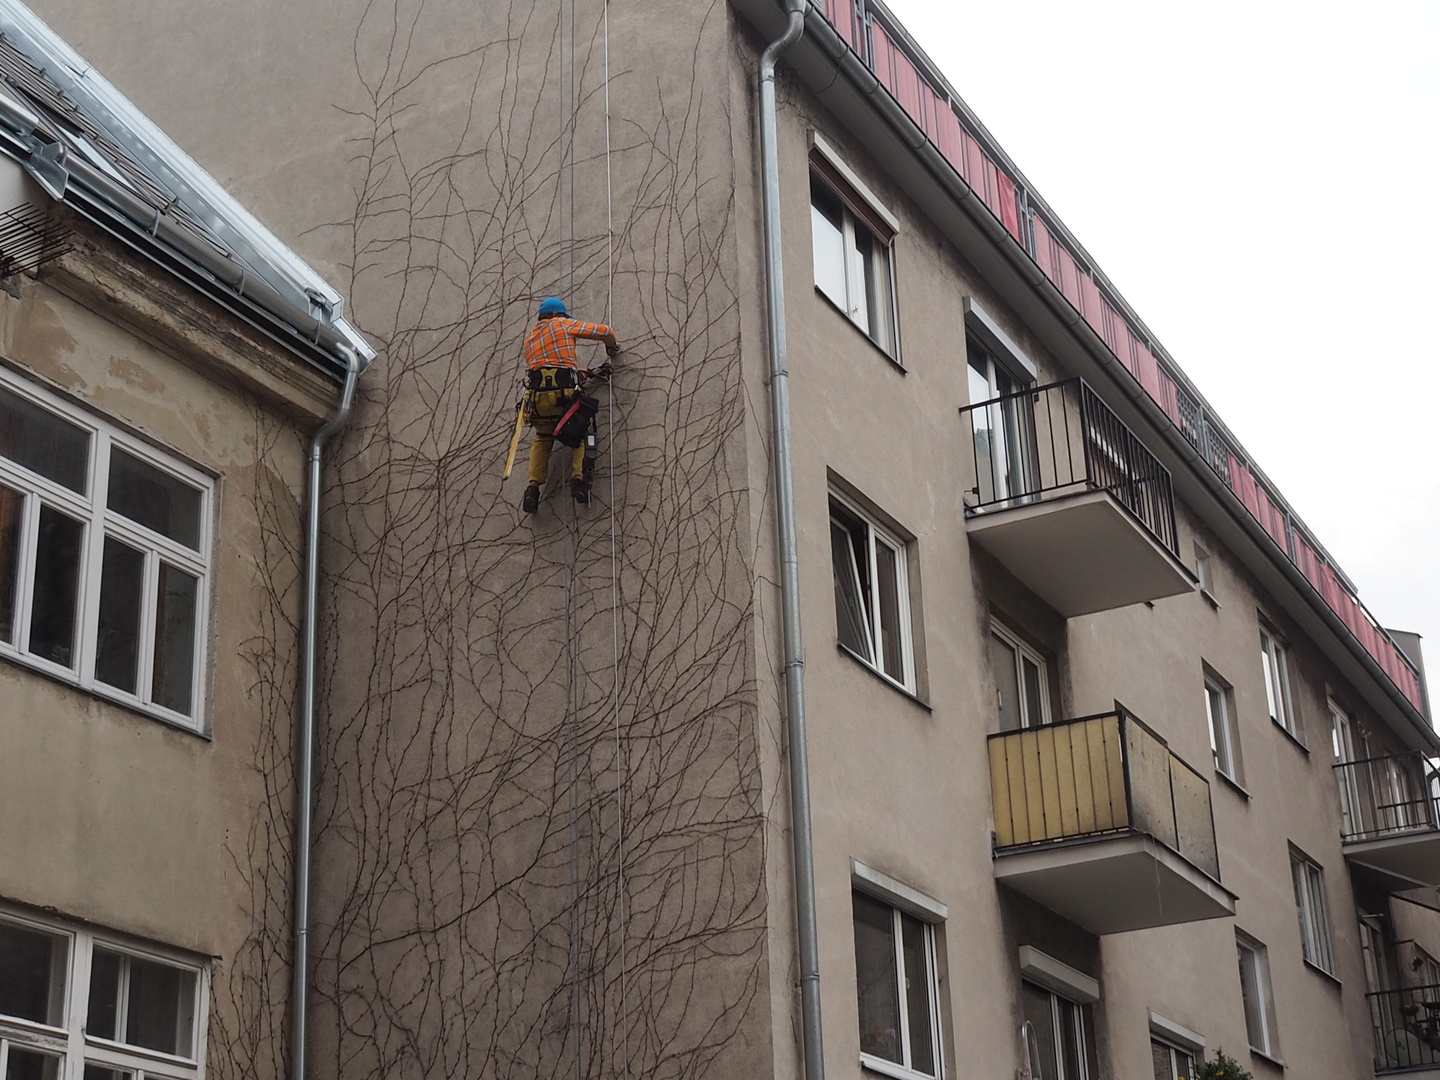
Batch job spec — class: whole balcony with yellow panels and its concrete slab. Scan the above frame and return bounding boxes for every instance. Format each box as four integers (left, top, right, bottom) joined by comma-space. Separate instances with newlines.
989, 706, 1236, 935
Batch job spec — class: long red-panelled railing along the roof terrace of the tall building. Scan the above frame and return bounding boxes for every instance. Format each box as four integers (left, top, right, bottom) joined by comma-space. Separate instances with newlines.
811, 0, 1424, 708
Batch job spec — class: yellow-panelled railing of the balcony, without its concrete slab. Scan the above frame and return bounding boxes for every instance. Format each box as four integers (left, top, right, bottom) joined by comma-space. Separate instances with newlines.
989, 706, 1220, 881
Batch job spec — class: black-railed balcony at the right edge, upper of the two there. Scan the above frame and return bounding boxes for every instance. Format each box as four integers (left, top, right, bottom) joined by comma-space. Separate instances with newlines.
1335, 753, 1440, 891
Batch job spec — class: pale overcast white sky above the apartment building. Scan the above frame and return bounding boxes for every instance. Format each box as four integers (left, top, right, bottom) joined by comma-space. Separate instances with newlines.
887, 0, 1440, 668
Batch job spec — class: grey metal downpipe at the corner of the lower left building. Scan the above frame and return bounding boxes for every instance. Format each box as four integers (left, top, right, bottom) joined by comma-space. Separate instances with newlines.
289, 346, 360, 1080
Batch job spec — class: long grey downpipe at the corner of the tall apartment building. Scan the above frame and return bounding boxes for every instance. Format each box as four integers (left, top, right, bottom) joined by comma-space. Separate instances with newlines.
760, 0, 825, 1080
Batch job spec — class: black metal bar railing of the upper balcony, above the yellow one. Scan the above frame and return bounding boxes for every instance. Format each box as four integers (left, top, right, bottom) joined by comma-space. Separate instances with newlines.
960, 379, 1178, 556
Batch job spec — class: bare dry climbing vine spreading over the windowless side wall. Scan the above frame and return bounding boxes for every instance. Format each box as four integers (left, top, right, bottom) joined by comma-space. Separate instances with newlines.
212, 0, 768, 1080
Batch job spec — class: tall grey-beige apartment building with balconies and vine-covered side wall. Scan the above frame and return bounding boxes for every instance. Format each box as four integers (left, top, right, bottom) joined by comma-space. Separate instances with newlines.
11, 0, 1440, 1080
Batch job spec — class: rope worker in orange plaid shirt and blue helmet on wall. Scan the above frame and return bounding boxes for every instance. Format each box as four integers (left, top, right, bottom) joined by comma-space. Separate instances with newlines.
507, 297, 621, 514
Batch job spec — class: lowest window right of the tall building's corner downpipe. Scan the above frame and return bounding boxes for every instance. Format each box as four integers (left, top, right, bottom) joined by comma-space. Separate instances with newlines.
851, 891, 940, 1076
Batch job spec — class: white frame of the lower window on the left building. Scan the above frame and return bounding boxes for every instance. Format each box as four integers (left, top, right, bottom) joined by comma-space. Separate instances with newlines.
0, 907, 210, 1080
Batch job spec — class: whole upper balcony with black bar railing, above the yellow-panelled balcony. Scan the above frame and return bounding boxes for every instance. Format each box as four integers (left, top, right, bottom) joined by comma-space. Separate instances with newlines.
960, 379, 1195, 618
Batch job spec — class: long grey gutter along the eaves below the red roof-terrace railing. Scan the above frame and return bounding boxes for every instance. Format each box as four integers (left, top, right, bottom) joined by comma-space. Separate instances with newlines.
732, 0, 1440, 752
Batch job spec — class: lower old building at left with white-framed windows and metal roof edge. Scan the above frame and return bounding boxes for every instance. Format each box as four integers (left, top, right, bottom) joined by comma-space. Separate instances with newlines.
0, 9, 369, 1080
